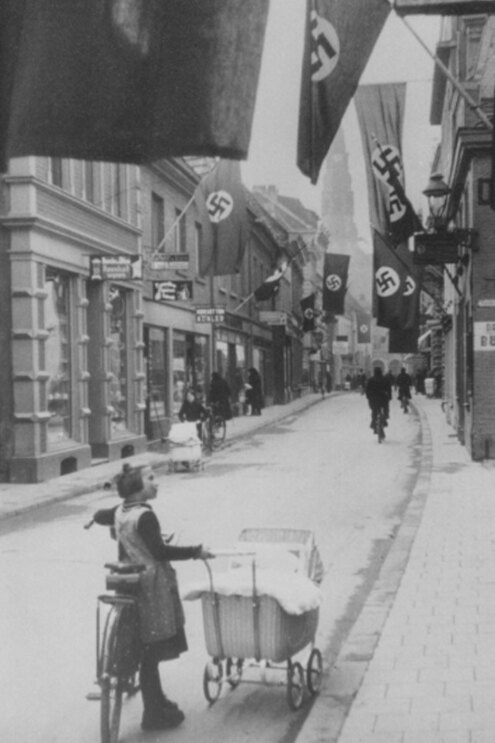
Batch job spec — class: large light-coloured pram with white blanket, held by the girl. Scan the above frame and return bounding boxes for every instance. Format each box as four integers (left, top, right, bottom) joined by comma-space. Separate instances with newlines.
184, 529, 323, 709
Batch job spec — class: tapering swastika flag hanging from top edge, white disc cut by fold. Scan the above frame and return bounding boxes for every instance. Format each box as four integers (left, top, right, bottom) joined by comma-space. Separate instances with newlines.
297, 0, 390, 183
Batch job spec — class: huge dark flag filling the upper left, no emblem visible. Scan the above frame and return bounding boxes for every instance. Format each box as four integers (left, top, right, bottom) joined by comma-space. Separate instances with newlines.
0, 0, 269, 170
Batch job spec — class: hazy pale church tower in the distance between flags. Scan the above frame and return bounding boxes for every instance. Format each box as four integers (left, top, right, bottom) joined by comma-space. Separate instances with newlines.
321, 127, 371, 308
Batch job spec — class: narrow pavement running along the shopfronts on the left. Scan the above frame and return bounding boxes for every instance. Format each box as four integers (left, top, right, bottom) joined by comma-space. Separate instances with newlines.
0, 393, 326, 519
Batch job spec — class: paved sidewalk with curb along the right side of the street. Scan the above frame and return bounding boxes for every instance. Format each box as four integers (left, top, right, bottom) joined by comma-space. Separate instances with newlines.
297, 396, 495, 743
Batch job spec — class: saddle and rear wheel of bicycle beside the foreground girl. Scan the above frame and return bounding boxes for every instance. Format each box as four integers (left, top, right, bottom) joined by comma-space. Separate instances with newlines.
96, 562, 145, 743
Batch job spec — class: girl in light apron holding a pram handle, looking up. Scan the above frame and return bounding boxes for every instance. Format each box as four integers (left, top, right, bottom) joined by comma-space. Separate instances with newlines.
93, 463, 213, 730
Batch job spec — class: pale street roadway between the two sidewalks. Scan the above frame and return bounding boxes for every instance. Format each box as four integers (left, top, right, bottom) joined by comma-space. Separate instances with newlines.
0, 393, 420, 743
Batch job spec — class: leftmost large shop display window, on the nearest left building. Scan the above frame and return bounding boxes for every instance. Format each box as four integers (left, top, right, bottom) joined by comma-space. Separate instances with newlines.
44, 268, 72, 449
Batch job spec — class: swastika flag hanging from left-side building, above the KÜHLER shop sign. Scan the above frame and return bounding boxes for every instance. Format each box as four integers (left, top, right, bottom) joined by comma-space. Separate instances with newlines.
196, 160, 249, 276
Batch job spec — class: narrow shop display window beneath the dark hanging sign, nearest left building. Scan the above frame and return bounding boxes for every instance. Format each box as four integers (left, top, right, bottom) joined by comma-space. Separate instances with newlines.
109, 285, 128, 434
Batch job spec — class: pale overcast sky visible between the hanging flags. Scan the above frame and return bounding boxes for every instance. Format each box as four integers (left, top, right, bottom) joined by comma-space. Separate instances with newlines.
243, 0, 440, 251
